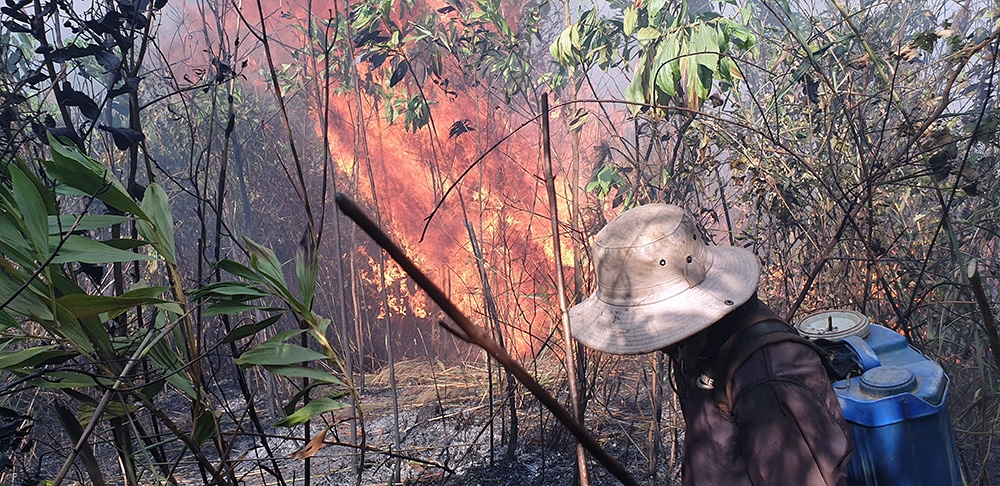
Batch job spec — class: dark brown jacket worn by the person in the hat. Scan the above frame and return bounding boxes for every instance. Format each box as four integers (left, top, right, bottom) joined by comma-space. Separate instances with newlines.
672, 299, 853, 486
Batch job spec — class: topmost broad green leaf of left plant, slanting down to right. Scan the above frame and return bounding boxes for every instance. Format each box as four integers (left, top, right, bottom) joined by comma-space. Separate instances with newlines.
43, 134, 146, 218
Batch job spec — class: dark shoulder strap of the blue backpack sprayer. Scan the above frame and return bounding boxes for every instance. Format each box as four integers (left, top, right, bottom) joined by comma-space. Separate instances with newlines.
715, 313, 833, 416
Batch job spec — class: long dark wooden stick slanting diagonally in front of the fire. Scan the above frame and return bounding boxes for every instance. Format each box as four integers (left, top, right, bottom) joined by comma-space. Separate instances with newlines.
337, 194, 639, 486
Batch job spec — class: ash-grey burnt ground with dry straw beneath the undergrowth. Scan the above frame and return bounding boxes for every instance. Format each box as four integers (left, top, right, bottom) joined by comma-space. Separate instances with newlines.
0, 357, 1000, 486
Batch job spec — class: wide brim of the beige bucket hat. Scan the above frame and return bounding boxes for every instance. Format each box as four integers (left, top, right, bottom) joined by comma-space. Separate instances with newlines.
569, 246, 760, 354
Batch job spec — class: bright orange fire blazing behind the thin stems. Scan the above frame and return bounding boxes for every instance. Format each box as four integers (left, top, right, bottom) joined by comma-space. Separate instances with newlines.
159, 1, 587, 356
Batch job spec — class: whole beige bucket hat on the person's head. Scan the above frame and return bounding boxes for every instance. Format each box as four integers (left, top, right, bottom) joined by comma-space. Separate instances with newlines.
569, 204, 760, 354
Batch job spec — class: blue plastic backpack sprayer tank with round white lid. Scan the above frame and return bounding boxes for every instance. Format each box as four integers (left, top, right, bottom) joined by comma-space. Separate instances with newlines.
795, 310, 962, 486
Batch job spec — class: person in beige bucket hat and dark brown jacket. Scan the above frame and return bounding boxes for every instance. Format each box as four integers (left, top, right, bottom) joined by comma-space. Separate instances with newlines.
569, 204, 853, 486
